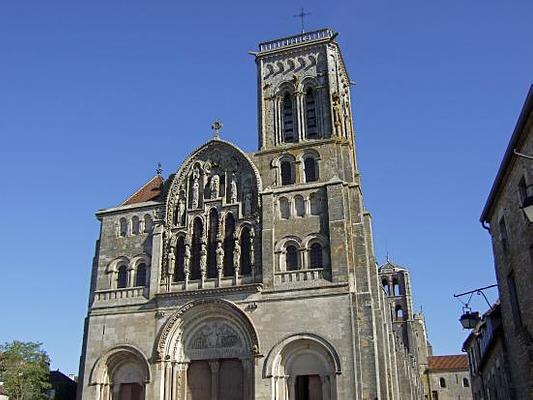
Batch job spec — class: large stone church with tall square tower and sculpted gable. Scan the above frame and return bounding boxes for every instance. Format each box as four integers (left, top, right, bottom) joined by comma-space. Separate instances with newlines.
78, 29, 427, 400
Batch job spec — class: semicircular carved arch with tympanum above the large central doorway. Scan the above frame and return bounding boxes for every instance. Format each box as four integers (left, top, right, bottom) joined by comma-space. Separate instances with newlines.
154, 299, 259, 362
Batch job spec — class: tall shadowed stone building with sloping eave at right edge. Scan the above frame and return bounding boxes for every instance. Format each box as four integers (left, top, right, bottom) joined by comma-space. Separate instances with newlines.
481, 87, 533, 400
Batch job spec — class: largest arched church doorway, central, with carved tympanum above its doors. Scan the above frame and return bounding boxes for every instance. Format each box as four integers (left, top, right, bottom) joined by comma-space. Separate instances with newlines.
156, 299, 259, 400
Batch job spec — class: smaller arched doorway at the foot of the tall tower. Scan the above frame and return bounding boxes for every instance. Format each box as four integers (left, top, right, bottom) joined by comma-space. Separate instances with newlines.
263, 334, 341, 400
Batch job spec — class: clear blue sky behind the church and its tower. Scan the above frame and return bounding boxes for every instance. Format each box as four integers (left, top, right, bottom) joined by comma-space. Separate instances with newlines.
0, 0, 533, 373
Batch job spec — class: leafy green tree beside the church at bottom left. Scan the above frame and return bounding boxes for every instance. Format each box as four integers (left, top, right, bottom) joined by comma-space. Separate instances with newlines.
0, 340, 50, 400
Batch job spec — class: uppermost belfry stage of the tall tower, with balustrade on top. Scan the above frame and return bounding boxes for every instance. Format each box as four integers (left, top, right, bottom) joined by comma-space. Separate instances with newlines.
255, 28, 353, 150
